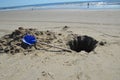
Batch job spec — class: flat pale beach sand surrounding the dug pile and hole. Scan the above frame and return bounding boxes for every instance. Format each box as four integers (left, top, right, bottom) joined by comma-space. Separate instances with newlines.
0, 9, 120, 80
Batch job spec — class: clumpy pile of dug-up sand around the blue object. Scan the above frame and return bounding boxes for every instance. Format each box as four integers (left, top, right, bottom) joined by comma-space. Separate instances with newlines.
0, 27, 67, 54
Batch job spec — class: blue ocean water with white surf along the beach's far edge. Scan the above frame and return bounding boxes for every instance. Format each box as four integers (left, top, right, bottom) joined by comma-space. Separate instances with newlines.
0, 0, 120, 10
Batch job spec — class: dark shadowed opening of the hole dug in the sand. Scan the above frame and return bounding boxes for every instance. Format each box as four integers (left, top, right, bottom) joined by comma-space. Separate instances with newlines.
68, 35, 98, 53
